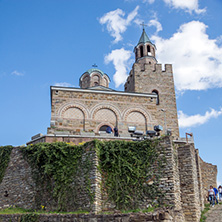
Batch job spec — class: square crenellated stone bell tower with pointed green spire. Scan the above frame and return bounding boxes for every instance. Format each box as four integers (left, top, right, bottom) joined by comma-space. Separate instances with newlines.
124, 27, 179, 138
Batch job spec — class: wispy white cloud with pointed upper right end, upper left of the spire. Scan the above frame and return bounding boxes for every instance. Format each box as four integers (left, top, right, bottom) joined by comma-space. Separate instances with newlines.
99, 6, 139, 43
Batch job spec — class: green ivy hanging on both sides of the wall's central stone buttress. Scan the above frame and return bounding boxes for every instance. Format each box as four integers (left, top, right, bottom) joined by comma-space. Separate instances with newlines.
22, 139, 164, 211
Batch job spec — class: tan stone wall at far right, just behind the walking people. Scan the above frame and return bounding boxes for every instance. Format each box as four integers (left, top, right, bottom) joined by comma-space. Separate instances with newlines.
200, 158, 217, 203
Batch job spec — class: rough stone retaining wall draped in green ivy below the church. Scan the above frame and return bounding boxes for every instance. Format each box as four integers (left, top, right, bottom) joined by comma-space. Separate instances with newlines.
0, 137, 181, 212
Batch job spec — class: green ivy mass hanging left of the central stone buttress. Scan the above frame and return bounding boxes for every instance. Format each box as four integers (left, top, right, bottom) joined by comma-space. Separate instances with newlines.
23, 142, 93, 211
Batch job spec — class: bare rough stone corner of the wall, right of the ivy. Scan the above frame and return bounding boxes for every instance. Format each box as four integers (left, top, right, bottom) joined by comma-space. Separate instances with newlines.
101, 137, 184, 222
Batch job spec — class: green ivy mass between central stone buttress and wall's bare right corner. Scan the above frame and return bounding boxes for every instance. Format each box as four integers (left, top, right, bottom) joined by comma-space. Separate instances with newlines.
96, 140, 163, 209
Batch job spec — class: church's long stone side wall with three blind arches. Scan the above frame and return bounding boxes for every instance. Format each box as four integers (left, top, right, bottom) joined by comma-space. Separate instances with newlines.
48, 87, 164, 136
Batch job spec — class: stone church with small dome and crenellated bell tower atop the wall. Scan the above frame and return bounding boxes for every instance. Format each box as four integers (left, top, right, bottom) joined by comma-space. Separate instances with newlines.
30, 29, 179, 143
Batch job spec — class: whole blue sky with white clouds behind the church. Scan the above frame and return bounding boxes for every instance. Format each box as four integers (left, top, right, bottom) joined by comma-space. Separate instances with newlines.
0, 0, 222, 185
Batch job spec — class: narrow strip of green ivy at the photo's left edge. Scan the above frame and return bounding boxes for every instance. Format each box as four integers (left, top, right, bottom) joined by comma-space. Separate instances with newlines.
0, 146, 12, 183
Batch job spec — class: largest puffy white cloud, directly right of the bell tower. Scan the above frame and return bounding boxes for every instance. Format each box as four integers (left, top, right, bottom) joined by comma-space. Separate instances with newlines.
151, 21, 222, 92
